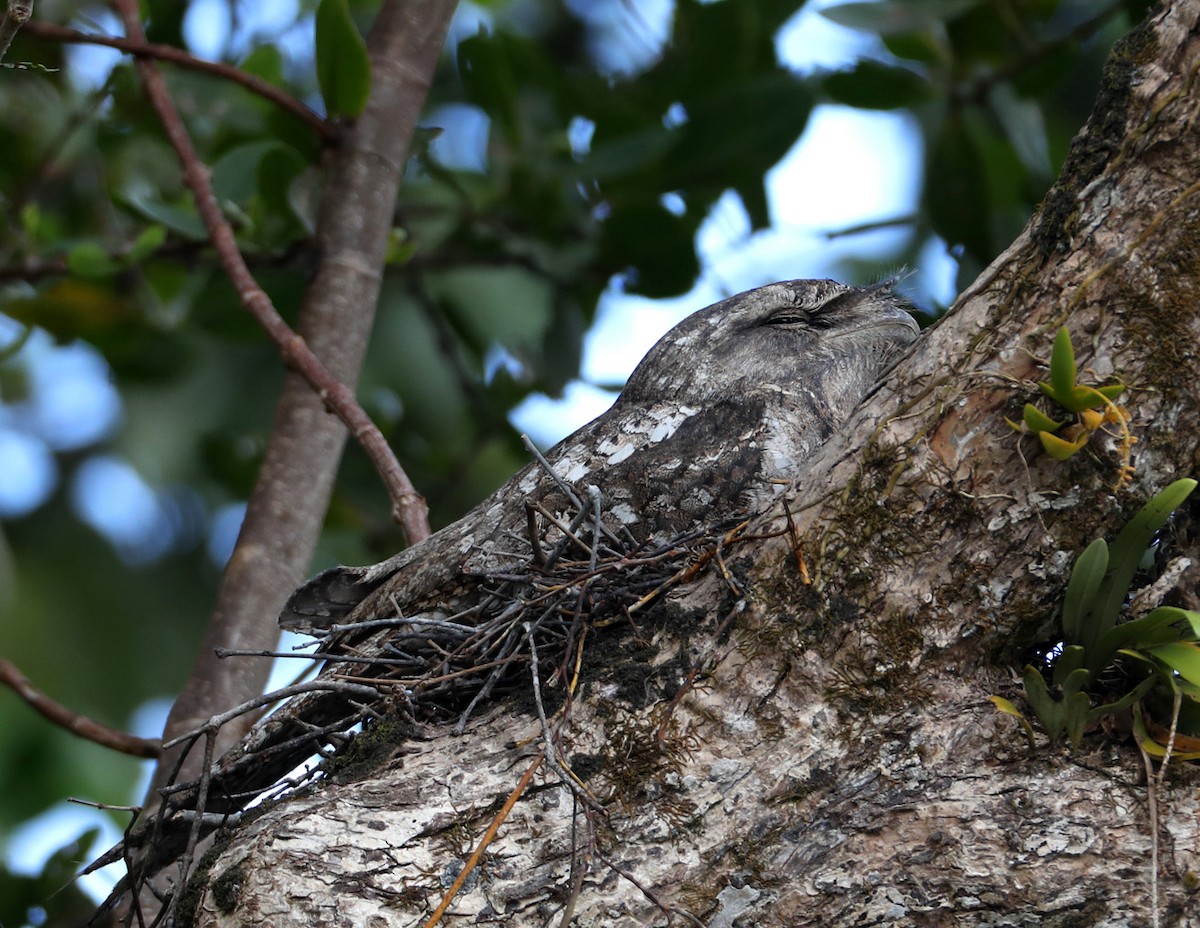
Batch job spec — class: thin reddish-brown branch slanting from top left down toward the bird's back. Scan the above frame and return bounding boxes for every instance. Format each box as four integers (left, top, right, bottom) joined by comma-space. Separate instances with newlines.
115, 0, 430, 545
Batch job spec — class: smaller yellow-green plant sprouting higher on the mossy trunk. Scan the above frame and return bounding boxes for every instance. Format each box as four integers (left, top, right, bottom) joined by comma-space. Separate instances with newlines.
1006, 327, 1136, 489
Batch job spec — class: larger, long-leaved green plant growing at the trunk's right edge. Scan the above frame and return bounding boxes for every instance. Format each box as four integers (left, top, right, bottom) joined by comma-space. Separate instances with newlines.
991, 479, 1200, 753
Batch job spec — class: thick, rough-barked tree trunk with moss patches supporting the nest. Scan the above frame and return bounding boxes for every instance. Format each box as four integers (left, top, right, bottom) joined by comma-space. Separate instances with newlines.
174, 0, 1200, 928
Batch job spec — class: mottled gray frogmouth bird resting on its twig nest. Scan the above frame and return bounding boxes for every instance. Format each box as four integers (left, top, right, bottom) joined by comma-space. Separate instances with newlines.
280, 280, 917, 630
